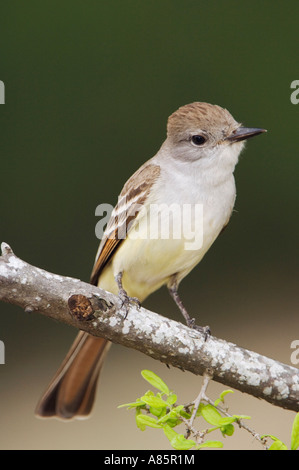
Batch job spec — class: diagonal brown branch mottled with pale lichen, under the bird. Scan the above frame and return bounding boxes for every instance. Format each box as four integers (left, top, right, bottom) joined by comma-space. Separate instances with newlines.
0, 243, 299, 411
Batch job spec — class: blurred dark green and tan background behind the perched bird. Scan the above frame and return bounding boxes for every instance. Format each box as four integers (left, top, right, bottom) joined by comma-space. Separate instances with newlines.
0, 0, 299, 449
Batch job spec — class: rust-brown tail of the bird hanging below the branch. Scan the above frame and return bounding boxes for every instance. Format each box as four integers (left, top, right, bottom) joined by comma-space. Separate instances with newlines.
36, 331, 111, 419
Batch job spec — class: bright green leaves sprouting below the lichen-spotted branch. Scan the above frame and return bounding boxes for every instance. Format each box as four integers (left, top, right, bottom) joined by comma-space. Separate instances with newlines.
119, 370, 299, 450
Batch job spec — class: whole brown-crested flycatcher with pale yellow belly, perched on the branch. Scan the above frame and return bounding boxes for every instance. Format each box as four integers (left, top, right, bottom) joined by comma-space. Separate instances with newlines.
36, 102, 265, 419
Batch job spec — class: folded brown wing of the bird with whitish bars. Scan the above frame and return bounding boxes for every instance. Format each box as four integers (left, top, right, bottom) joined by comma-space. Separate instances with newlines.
90, 162, 160, 285
